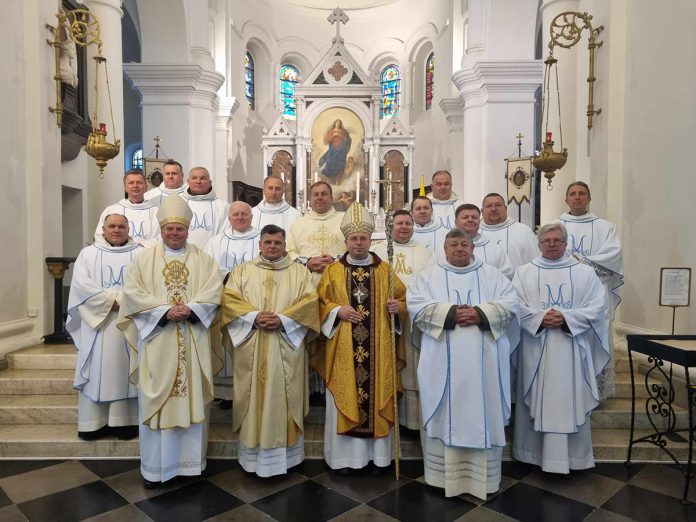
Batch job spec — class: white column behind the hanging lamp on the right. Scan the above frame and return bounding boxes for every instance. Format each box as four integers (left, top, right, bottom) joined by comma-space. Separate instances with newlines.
540, 0, 589, 223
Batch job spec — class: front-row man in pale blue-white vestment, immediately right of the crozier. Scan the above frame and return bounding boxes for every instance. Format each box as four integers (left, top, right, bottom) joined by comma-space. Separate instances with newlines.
407, 229, 519, 499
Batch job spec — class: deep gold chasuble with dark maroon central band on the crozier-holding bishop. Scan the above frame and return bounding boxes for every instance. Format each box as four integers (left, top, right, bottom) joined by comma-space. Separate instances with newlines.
311, 253, 407, 438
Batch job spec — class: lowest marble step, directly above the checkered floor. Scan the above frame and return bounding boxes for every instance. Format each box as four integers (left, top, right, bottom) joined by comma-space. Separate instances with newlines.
0, 424, 688, 462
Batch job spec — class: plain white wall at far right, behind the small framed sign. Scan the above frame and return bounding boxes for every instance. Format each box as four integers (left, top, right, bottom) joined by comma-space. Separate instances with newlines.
610, 0, 696, 333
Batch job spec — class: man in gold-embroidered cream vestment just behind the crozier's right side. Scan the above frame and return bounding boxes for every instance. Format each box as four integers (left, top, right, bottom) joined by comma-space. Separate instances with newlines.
373, 210, 433, 430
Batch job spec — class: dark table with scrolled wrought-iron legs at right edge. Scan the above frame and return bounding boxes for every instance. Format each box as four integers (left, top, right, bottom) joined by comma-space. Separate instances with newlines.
626, 335, 696, 503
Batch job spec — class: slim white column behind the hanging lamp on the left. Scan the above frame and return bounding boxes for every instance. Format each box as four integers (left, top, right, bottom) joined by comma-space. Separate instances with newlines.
84, 0, 124, 230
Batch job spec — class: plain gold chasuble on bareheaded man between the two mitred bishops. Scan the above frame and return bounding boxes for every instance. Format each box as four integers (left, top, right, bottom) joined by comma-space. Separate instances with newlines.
221, 255, 319, 449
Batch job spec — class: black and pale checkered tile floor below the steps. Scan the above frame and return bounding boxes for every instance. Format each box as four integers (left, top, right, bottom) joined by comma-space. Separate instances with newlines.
0, 460, 696, 522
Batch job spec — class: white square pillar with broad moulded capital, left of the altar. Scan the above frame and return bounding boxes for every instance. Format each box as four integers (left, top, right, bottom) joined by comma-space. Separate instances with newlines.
123, 63, 224, 175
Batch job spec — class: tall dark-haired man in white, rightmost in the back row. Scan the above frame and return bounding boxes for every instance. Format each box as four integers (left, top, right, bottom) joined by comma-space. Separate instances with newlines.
560, 181, 624, 400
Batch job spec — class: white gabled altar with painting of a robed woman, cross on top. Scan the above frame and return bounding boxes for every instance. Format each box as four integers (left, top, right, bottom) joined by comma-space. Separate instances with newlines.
261, 9, 419, 224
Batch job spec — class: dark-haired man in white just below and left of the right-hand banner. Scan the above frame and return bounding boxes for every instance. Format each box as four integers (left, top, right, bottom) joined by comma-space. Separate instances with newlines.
480, 192, 539, 269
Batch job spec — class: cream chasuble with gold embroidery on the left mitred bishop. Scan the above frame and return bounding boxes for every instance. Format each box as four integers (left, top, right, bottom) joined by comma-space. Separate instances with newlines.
118, 243, 222, 429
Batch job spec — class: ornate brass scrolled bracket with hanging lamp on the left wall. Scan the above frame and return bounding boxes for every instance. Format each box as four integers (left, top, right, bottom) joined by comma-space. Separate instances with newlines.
46, 9, 121, 177
